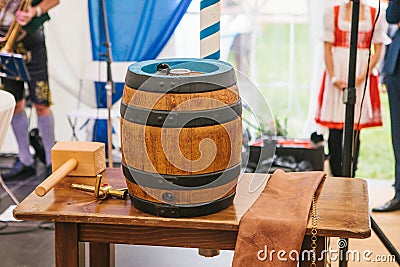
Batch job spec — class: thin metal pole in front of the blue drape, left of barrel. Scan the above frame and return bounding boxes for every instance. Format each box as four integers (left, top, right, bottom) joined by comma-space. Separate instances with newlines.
101, 0, 115, 168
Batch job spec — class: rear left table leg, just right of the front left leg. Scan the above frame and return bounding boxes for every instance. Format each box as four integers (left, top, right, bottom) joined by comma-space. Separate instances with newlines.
89, 242, 115, 267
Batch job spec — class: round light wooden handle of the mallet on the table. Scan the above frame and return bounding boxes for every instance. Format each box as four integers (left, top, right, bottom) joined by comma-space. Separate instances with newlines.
35, 158, 78, 197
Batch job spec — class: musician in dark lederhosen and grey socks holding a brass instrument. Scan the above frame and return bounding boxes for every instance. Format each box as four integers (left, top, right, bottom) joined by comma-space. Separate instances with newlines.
0, 0, 59, 180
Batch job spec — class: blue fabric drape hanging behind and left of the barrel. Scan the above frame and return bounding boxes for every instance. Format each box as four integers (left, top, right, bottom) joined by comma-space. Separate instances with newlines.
88, 0, 191, 147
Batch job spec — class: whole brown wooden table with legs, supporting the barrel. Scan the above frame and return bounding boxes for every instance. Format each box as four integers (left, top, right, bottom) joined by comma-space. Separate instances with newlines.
14, 168, 371, 267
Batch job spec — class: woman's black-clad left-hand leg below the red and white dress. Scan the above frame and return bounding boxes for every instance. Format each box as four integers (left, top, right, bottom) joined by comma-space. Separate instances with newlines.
328, 129, 343, 176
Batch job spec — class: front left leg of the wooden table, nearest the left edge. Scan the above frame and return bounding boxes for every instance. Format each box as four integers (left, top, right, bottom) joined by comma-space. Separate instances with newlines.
55, 223, 79, 267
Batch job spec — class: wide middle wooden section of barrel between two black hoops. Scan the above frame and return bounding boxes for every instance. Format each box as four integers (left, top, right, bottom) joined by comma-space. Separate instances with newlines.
121, 118, 242, 175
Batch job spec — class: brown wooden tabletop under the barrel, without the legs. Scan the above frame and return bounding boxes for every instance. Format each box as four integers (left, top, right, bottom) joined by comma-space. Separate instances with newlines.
14, 168, 371, 238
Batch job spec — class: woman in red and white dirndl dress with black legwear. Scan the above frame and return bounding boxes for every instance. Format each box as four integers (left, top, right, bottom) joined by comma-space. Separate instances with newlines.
315, 1, 387, 179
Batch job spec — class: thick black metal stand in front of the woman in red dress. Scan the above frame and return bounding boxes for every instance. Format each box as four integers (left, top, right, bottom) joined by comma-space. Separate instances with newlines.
339, 0, 400, 267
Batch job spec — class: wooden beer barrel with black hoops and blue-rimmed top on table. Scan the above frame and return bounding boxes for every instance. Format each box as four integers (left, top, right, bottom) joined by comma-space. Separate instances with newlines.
120, 59, 242, 217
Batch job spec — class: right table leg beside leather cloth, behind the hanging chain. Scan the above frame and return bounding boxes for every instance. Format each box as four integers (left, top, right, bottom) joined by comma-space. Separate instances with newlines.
299, 236, 327, 267
